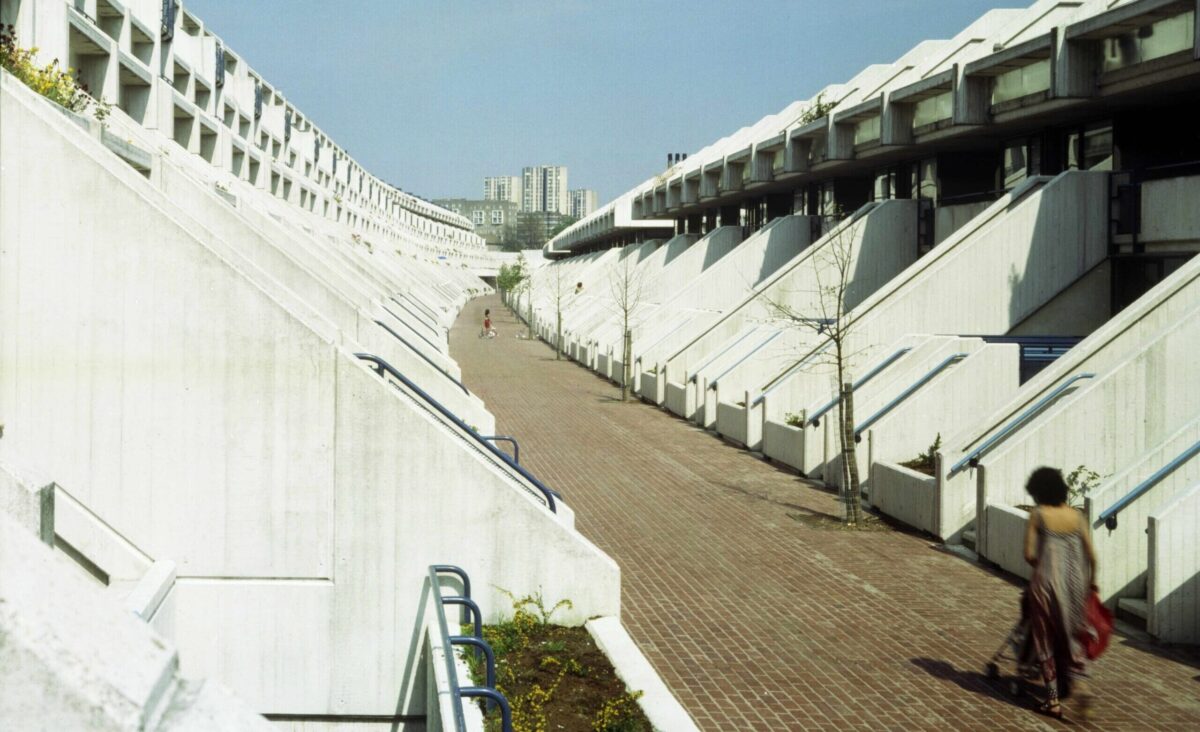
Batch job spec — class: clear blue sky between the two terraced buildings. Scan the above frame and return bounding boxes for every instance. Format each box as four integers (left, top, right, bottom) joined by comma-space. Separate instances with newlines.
185, 0, 1012, 202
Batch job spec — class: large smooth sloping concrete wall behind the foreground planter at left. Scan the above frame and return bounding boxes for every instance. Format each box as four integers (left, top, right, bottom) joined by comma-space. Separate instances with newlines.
0, 68, 619, 715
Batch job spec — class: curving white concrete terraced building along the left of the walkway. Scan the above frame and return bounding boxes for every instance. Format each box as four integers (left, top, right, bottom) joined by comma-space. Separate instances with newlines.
0, 0, 686, 731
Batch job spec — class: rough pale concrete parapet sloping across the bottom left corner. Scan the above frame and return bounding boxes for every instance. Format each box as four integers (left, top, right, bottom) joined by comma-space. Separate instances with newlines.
0, 511, 270, 732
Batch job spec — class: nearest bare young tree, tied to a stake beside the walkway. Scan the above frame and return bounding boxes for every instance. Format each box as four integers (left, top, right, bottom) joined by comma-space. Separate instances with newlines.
767, 211, 863, 526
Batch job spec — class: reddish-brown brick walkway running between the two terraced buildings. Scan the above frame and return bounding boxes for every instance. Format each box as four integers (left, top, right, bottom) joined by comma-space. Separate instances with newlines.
451, 298, 1200, 731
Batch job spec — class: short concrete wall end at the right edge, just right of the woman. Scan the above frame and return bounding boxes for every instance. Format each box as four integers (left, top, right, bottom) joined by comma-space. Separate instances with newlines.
1146, 484, 1200, 643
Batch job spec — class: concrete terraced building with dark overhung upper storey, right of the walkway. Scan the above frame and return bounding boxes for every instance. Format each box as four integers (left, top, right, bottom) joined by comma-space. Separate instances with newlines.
535, 0, 1200, 643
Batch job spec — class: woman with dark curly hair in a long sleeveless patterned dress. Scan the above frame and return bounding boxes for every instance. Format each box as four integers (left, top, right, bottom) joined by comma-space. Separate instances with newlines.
1025, 468, 1096, 719
